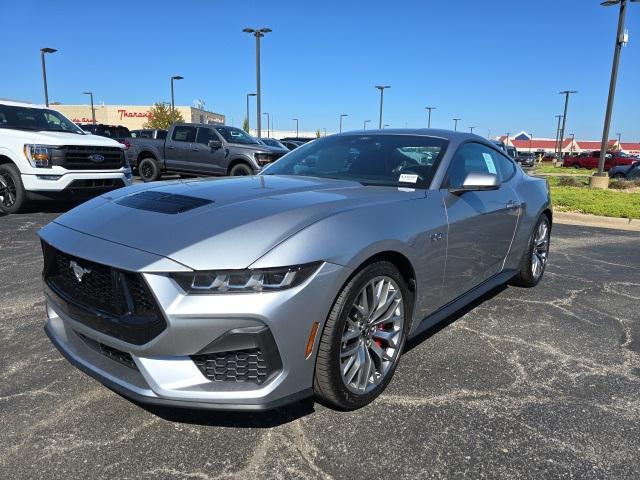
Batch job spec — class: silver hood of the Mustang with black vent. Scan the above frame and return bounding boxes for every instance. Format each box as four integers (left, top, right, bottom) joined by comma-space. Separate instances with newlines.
55, 175, 425, 270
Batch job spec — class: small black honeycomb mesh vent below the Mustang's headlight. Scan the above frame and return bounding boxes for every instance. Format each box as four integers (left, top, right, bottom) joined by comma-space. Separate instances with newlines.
191, 348, 270, 385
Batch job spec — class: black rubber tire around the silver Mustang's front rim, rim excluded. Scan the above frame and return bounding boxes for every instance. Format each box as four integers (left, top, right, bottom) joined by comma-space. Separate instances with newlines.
313, 261, 413, 410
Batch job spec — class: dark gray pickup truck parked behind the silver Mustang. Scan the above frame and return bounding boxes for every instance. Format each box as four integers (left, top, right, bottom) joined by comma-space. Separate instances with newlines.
127, 123, 288, 182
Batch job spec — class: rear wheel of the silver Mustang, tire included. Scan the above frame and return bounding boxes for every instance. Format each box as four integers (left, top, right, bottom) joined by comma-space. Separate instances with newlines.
511, 215, 551, 287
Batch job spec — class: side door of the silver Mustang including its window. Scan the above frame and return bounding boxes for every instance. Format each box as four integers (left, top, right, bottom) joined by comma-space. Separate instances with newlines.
440, 142, 520, 301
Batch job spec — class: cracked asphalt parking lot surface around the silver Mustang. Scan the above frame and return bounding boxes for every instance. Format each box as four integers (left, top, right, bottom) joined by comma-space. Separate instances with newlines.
0, 208, 640, 479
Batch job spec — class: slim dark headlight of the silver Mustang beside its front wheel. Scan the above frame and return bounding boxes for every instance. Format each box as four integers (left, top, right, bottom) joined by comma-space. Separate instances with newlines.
171, 262, 322, 294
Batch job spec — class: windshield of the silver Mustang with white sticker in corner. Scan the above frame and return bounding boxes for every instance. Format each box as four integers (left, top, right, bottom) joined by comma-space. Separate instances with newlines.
263, 135, 447, 188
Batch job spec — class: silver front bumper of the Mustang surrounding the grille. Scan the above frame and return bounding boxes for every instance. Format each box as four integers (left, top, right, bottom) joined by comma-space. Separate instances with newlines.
45, 232, 350, 410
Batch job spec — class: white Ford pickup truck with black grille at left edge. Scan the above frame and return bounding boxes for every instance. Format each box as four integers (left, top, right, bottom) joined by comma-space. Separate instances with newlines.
0, 99, 132, 213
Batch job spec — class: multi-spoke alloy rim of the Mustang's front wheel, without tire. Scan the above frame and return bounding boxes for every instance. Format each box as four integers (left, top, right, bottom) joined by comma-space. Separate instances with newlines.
340, 276, 405, 394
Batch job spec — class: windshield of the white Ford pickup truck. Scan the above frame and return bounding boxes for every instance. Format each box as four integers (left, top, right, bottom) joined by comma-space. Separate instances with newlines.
0, 104, 84, 135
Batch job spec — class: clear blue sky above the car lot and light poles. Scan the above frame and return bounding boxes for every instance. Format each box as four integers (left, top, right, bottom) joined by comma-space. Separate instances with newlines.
0, 0, 640, 141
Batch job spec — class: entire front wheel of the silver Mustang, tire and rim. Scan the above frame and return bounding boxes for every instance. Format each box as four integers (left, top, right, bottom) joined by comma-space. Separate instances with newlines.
313, 261, 411, 410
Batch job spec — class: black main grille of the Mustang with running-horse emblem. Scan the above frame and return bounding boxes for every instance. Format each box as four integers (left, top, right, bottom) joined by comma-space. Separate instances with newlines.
42, 242, 167, 345
